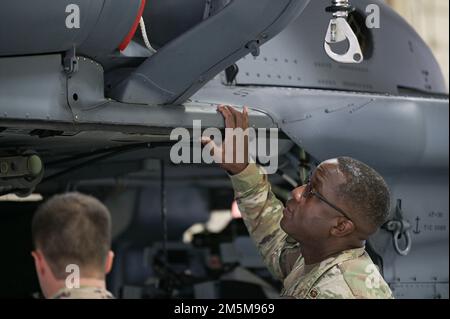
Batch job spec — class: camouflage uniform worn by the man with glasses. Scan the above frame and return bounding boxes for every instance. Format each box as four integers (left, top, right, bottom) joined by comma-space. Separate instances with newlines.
230, 164, 393, 299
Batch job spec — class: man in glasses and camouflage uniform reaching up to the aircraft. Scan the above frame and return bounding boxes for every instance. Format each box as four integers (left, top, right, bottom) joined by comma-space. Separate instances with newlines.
202, 106, 393, 299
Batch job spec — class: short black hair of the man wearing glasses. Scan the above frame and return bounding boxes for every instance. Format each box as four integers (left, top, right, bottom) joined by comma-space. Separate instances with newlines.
338, 157, 391, 233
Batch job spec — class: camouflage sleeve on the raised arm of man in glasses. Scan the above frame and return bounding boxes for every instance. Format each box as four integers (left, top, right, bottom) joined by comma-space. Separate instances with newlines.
230, 164, 300, 280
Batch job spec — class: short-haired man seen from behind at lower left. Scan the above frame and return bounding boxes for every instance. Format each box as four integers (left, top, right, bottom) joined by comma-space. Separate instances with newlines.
32, 193, 114, 299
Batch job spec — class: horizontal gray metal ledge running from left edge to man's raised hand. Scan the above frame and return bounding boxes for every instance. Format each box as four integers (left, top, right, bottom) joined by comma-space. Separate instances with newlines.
0, 55, 274, 133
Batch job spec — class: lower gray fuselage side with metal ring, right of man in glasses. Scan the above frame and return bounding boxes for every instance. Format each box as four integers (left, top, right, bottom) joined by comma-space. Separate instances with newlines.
372, 172, 449, 298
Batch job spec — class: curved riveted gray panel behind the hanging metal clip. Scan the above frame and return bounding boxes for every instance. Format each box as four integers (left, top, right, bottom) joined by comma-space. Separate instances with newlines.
236, 0, 448, 94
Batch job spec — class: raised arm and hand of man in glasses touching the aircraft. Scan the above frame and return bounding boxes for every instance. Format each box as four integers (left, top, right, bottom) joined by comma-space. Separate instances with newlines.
202, 106, 299, 279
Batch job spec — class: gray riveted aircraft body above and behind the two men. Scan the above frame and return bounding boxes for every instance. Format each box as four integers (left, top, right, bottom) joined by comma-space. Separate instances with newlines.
0, 0, 449, 298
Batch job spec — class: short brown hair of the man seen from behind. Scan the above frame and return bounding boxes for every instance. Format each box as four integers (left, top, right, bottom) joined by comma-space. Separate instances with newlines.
31, 192, 111, 279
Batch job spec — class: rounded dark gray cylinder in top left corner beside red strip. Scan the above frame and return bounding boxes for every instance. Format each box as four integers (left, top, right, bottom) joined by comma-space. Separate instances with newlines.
0, 0, 141, 57
